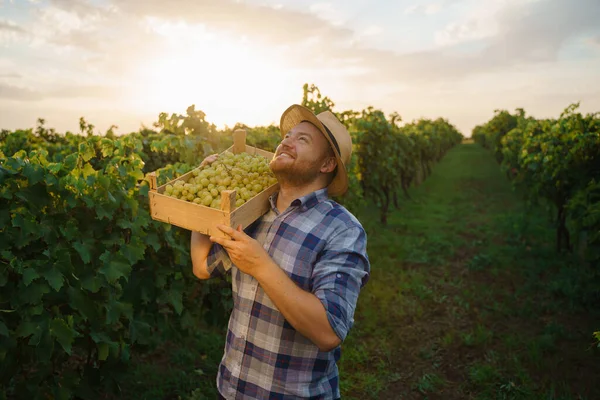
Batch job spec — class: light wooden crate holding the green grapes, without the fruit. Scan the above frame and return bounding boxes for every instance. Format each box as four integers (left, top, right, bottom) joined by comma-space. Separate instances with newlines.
149, 129, 279, 237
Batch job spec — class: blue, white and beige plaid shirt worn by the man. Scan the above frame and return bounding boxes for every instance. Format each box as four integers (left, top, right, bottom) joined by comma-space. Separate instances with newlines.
207, 189, 370, 400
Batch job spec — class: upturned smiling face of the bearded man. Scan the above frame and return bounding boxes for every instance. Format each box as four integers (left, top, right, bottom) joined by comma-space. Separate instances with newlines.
270, 122, 335, 185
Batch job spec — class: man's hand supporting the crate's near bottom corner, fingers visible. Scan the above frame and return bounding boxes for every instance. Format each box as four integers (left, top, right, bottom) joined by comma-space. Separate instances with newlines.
210, 225, 272, 278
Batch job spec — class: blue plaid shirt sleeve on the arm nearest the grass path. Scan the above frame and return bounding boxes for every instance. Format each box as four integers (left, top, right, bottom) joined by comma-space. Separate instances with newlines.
312, 225, 370, 341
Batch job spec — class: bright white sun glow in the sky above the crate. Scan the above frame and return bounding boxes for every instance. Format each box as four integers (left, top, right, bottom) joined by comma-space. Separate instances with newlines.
132, 19, 298, 126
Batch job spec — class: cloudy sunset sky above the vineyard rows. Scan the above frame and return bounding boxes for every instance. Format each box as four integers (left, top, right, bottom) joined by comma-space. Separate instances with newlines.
0, 0, 600, 136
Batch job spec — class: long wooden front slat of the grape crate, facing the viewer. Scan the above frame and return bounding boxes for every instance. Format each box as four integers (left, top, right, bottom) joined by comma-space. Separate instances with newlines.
149, 192, 231, 237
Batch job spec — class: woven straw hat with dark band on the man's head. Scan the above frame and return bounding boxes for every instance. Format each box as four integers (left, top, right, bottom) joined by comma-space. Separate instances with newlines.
279, 104, 352, 196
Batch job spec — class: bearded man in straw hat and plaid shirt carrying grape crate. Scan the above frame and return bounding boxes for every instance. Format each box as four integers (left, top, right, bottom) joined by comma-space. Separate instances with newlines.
191, 105, 370, 399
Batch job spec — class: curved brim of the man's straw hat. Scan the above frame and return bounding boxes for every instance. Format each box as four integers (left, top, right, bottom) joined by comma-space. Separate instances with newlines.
279, 104, 348, 196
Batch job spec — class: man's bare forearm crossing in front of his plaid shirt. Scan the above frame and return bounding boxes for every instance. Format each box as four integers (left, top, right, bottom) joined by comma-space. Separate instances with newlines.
255, 260, 341, 351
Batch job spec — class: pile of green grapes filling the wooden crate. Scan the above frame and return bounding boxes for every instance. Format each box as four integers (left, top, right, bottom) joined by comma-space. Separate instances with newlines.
165, 151, 277, 208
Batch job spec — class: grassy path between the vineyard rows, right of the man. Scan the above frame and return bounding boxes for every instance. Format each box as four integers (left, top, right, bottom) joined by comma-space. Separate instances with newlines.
340, 144, 600, 399
